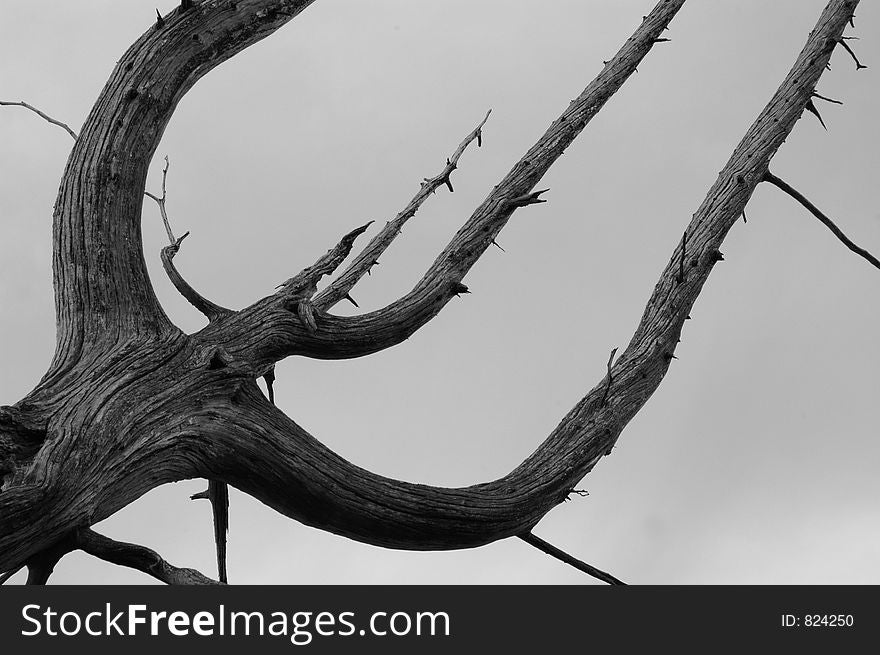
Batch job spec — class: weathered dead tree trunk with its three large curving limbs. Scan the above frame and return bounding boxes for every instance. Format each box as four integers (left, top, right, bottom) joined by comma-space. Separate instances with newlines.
0, 0, 858, 584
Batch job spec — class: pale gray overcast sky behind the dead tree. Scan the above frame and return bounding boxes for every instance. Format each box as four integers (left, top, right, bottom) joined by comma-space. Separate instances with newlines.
0, 0, 880, 584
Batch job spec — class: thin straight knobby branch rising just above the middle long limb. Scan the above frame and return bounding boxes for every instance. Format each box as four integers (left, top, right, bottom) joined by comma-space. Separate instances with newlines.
315, 109, 492, 311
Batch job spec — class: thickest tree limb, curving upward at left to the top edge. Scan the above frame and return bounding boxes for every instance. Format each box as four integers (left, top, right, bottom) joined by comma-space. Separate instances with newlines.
48, 0, 313, 380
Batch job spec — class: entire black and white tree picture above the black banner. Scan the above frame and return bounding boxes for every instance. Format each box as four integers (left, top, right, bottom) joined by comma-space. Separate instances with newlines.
0, 0, 880, 644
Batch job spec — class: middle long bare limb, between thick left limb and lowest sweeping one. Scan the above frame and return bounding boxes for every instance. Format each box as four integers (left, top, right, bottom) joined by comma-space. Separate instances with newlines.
202, 0, 684, 370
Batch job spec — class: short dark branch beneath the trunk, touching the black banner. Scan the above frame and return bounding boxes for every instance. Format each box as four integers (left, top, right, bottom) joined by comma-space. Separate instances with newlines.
76, 529, 222, 585
